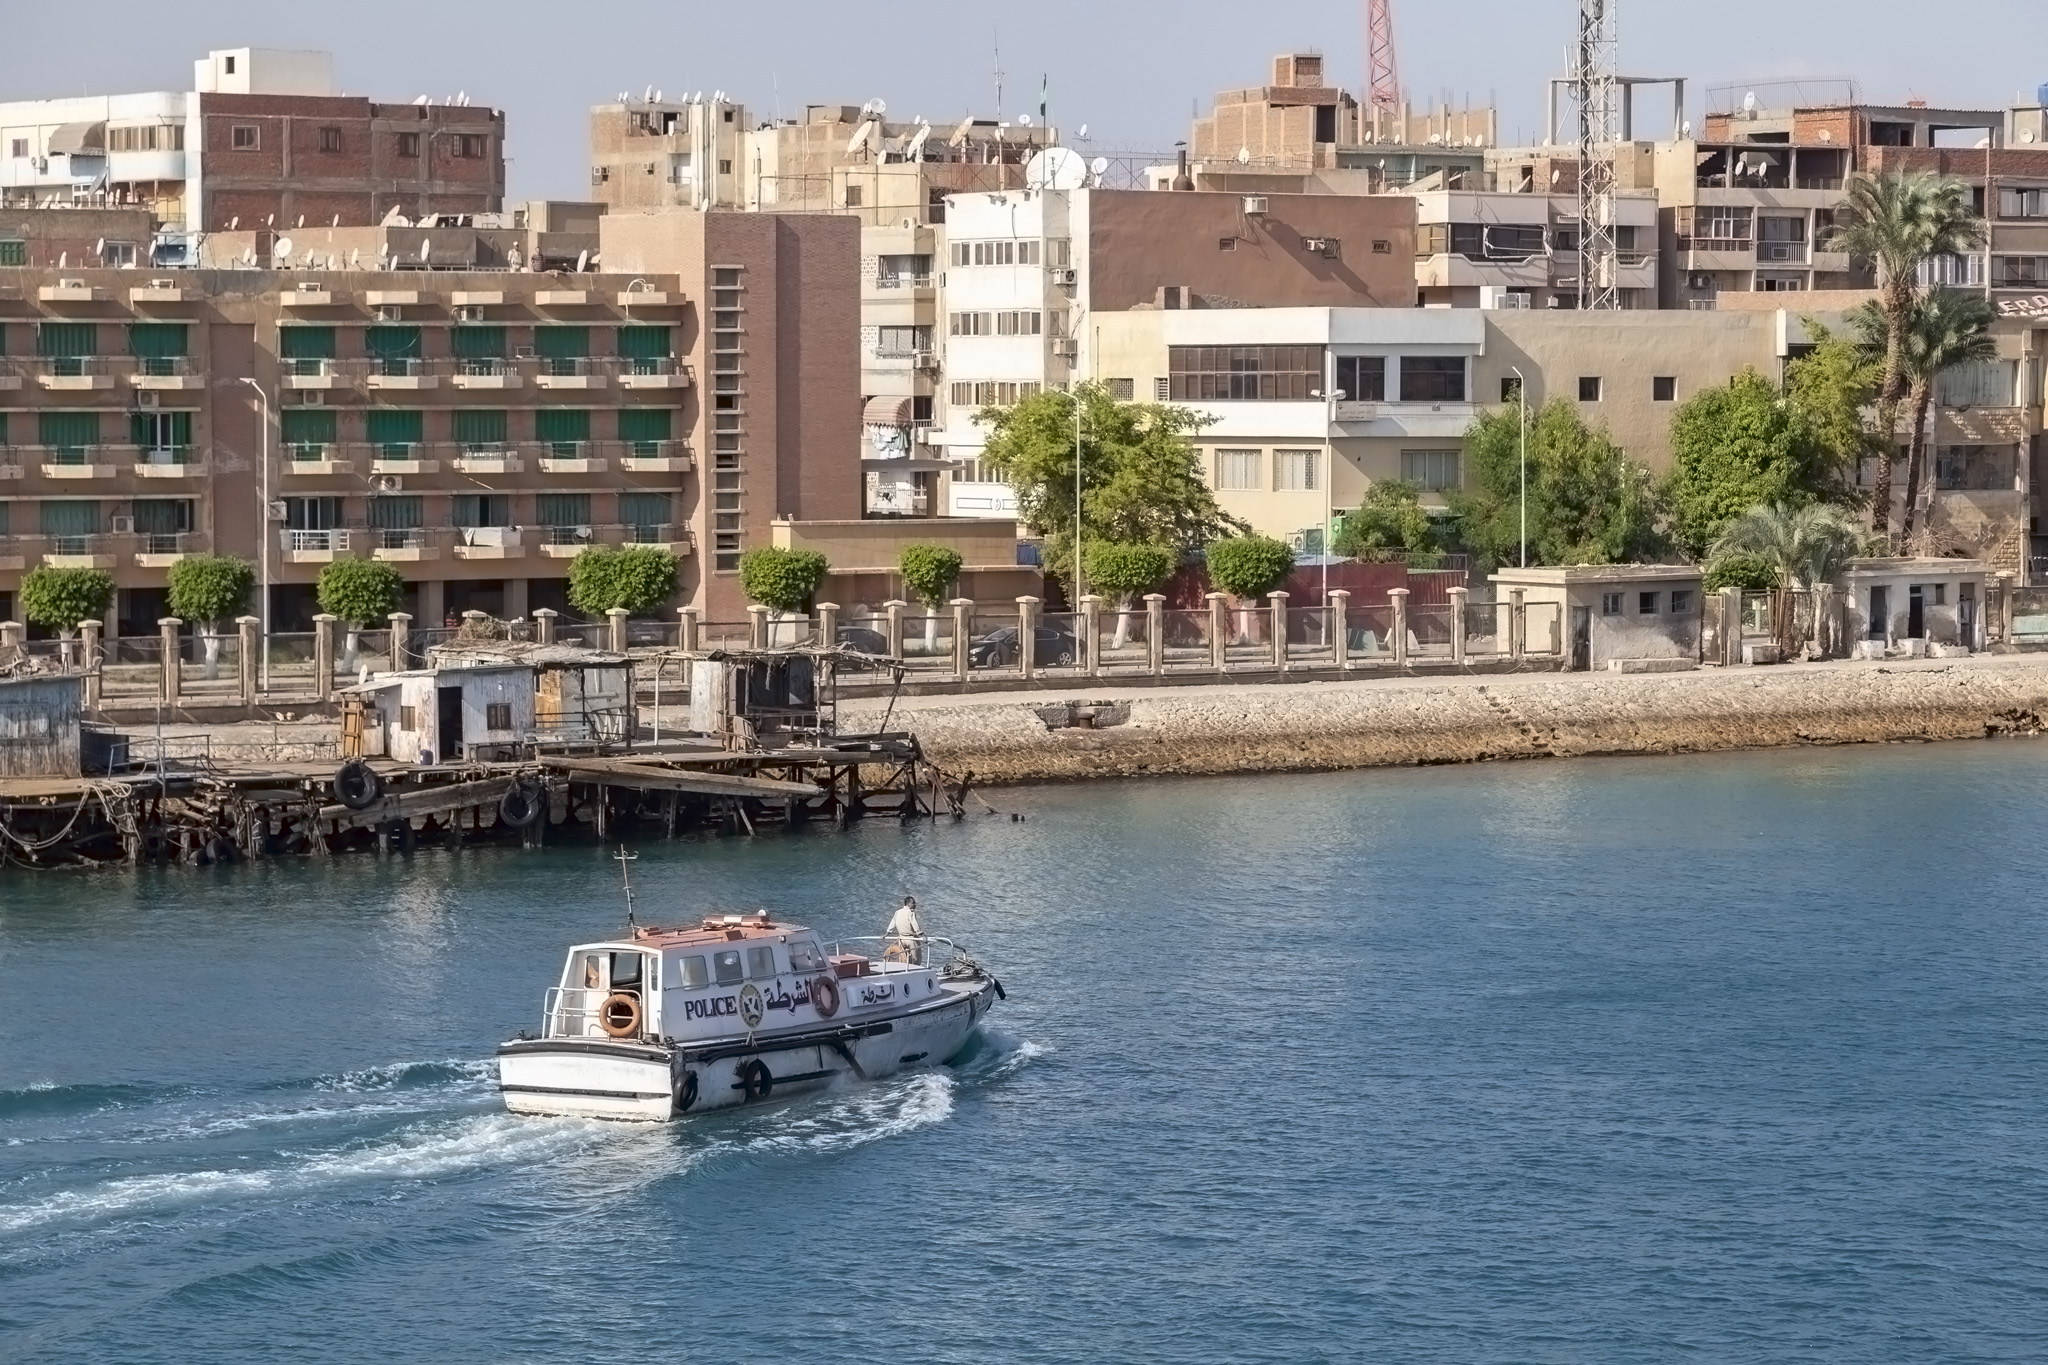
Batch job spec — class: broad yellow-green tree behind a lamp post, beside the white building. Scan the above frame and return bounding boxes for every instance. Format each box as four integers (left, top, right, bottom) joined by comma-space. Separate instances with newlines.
975, 383, 1245, 601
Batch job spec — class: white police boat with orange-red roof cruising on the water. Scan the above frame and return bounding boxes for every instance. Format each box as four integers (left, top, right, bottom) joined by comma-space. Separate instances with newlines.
498, 900, 1004, 1121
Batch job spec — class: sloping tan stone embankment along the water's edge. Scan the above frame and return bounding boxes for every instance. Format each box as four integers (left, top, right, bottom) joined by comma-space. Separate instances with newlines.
842, 655, 2048, 784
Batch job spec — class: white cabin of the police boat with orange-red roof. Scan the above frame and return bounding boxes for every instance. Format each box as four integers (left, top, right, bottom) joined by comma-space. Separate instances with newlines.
543, 913, 940, 1044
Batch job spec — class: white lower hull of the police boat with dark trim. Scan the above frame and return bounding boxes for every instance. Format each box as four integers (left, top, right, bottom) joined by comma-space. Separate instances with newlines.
498, 978, 997, 1121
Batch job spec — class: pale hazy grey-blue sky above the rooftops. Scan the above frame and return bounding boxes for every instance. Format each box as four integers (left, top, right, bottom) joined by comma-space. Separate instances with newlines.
0, 0, 2048, 201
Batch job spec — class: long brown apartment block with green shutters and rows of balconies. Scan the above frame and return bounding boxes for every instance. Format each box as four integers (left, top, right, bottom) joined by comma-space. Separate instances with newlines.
0, 211, 858, 636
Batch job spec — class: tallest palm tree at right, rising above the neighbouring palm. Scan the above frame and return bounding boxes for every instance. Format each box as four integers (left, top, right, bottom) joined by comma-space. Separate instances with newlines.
1827, 172, 1985, 534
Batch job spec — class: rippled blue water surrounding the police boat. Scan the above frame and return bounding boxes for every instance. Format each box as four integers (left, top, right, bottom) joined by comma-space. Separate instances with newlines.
0, 743, 2048, 1365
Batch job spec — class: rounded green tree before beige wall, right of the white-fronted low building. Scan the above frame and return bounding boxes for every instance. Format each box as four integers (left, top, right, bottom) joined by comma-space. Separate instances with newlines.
1448, 399, 1667, 569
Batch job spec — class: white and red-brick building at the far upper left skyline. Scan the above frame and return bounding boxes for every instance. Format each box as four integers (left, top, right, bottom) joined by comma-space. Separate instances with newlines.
0, 47, 506, 266
